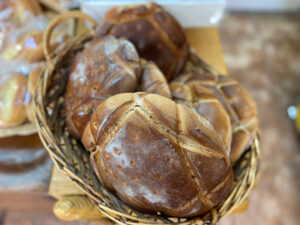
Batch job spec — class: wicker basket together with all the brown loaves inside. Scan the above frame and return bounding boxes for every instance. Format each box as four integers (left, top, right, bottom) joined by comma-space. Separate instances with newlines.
34, 3, 260, 224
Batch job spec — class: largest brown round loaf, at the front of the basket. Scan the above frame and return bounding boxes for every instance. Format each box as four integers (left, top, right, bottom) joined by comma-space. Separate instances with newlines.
82, 93, 233, 217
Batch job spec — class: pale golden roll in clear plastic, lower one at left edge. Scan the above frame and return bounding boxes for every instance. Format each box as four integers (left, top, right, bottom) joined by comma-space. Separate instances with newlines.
0, 74, 28, 127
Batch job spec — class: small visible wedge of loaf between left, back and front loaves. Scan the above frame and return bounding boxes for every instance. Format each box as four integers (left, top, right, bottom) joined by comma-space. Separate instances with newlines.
138, 59, 172, 99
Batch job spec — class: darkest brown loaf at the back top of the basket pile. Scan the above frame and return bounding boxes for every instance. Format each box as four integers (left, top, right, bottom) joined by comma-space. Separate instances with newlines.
95, 3, 189, 80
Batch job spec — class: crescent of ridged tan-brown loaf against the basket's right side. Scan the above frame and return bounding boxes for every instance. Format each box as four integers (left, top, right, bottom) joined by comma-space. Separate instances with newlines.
172, 72, 258, 163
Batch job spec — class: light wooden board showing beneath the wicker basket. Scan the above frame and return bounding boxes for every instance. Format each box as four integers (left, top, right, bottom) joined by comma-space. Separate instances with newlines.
49, 27, 227, 199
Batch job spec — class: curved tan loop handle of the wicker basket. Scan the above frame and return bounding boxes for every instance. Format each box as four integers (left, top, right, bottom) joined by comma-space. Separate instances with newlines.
43, 11, 97, 61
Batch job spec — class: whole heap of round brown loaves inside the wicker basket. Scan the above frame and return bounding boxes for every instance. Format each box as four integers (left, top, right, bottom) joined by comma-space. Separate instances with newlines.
63, 0, 258, 217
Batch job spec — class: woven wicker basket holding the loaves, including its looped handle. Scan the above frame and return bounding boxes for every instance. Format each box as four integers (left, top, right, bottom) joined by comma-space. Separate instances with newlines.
35, 12, 260, 224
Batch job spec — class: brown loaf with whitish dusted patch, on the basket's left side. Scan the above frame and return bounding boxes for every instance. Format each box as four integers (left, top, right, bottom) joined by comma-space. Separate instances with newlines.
64, 36, 140, 139
